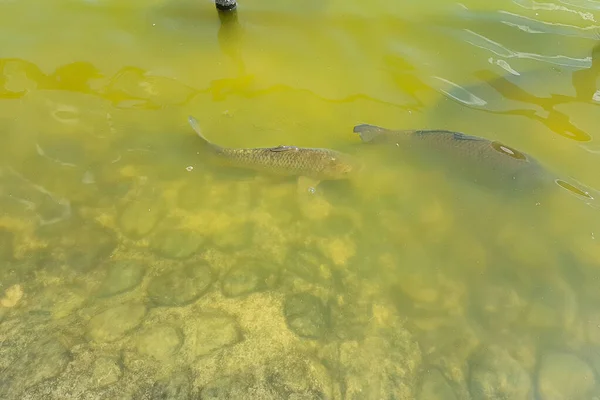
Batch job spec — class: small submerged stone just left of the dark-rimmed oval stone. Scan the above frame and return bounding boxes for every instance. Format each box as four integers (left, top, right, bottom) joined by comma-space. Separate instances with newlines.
97, 260, 146, 297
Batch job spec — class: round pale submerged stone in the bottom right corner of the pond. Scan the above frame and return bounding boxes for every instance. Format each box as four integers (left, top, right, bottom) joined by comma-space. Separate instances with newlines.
538, 352, 596, 400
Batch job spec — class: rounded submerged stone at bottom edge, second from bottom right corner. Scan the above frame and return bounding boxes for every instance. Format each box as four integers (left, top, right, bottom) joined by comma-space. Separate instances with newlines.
470, 346, 533, 400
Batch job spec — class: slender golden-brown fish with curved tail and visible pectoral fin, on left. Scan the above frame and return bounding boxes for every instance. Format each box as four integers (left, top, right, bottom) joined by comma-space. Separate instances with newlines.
188, 116, 361, 193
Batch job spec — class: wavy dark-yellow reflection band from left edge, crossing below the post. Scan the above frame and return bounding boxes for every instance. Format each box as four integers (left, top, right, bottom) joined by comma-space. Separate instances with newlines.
0, 55, 412, 113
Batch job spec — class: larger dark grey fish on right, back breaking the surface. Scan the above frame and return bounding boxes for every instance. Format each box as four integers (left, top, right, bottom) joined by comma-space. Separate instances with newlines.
353, 124, 554, 190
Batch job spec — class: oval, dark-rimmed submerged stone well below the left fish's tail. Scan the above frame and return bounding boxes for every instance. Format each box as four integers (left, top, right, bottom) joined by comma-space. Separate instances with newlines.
148, 263, 213, 307
